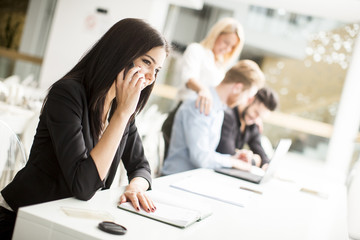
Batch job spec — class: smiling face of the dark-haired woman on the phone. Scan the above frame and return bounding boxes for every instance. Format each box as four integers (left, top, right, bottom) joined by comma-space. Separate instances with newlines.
134, 47, 166, 90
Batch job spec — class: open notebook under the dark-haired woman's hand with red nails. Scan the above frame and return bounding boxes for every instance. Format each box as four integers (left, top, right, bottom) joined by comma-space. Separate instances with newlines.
118, 190, 212, 228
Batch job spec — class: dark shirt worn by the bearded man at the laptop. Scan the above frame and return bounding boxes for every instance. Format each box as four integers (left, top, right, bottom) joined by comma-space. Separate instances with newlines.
216, 107, 270, 166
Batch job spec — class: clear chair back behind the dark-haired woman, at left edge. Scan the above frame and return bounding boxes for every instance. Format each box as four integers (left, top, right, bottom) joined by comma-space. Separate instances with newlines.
0, 120, 26, 190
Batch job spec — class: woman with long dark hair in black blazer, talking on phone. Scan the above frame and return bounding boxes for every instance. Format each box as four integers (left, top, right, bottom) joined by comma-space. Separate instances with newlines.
0, 19, 169, 239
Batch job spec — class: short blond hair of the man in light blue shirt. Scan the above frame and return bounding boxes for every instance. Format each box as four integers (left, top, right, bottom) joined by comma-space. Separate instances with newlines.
222, 59, 265, 89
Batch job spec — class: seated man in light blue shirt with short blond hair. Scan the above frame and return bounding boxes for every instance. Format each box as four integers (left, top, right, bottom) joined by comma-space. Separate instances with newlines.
162, 60, 265, 175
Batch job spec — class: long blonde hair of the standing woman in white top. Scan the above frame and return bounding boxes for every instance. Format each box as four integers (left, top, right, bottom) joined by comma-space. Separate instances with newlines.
200, 17, 245, 67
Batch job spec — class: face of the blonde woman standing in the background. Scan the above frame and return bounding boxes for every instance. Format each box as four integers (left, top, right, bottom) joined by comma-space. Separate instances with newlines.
213, 33, 239, 58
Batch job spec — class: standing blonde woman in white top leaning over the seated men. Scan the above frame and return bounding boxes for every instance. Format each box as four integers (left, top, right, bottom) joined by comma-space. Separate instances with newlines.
162, 18, 245, 156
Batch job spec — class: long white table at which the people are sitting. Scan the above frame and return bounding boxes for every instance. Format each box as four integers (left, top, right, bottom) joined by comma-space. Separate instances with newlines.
13, 169, 348, 240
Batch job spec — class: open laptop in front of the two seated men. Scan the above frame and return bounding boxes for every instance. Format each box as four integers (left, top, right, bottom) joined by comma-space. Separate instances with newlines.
215, 139, 291, 184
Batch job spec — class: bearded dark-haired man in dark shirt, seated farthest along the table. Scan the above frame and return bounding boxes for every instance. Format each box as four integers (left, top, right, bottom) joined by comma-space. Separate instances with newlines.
216, 88, 278, 167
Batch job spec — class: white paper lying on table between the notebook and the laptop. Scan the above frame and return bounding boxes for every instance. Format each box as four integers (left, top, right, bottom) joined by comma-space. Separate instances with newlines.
170, 172, 254, 207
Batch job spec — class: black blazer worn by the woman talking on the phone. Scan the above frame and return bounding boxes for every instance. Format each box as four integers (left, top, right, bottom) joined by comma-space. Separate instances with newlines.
1, 80, 151, 211
